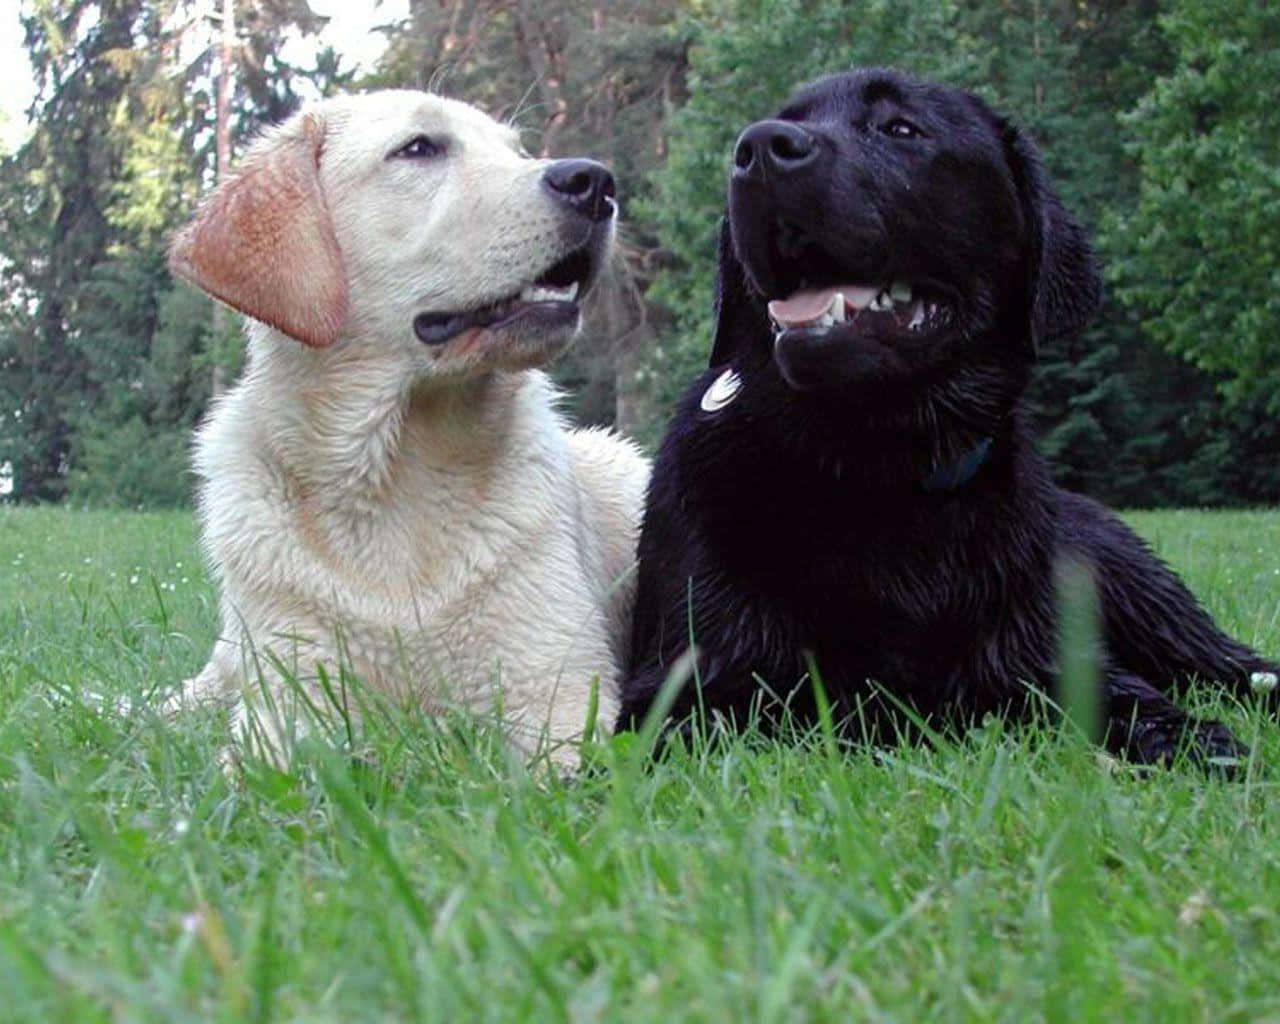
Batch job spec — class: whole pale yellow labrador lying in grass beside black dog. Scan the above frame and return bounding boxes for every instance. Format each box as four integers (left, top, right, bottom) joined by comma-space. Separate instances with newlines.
170, 91, 648, 764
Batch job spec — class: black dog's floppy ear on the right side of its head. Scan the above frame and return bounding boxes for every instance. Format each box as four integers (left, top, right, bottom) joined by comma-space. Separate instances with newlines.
1004, 123, 1102, 346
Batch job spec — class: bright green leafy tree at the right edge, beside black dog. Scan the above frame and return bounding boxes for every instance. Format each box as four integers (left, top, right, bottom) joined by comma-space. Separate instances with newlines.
1108, 0, 1280, 413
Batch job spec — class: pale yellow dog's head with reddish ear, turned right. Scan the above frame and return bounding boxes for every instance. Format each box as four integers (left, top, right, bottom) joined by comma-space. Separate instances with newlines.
170, 91, 616, 375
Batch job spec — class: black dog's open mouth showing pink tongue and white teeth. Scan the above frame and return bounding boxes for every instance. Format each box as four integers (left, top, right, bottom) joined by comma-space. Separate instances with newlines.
769, 280, 955, 337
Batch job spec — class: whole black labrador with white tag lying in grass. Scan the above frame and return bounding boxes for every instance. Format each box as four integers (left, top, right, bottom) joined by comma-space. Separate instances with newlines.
620, 69, 1277, 762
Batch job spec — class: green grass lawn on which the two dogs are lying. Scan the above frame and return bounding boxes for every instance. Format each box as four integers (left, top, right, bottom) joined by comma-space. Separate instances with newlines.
0, 508, 1280, 1021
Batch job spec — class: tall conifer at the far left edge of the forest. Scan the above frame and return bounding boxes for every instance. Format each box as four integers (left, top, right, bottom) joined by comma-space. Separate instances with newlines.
0, 0, 145, 500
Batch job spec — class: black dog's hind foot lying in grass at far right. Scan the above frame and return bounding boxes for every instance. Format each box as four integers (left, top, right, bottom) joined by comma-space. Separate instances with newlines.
1106, 671, 1249, 771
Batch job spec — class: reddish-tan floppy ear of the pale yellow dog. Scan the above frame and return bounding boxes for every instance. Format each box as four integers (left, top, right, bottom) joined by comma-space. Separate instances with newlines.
169, 114, 347, 348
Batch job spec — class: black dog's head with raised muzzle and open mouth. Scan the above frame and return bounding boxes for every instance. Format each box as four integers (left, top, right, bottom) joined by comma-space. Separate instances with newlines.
712, 69, 1101, 403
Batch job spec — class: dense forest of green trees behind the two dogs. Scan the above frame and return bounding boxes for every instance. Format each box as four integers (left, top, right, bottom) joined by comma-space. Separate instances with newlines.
0, 0, 1280, 507
